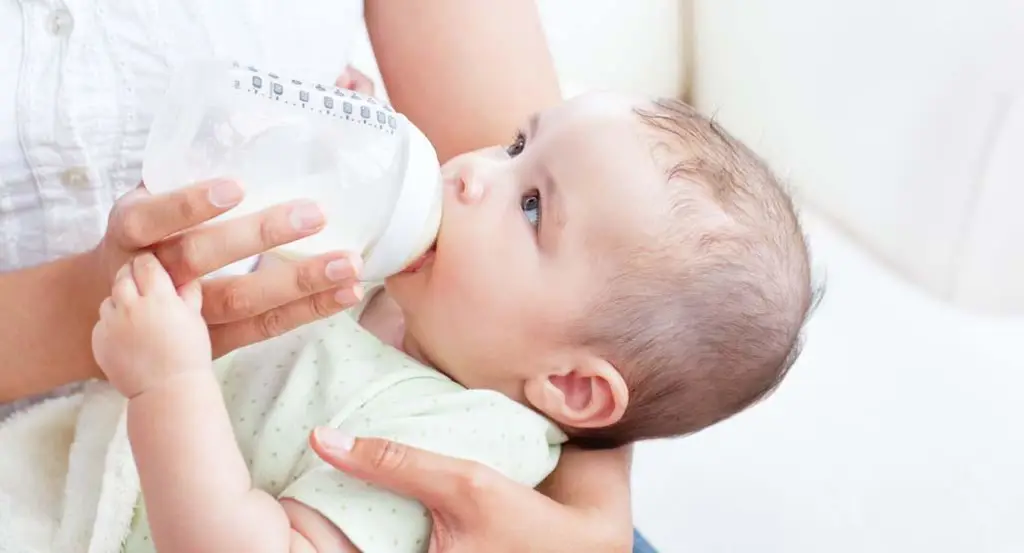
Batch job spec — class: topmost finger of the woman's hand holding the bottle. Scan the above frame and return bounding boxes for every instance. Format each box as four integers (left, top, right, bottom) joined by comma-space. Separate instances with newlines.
106, 180, 243, 252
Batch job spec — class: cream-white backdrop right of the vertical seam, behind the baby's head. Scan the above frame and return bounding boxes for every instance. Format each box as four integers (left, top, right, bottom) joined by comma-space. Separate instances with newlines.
693, 0, 1024, 312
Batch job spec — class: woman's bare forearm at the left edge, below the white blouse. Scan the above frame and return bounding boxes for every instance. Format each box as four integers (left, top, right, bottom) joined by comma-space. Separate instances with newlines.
0, 254, 110, 402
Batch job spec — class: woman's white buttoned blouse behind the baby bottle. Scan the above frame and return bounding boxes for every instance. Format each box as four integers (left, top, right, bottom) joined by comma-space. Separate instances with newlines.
0, 0, 362, 272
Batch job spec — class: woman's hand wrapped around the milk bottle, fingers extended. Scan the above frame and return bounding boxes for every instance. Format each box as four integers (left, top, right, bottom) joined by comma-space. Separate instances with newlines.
91, 181, 361, 357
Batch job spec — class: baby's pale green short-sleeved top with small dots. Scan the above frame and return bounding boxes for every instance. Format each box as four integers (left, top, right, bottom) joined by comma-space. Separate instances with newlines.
123, 286, 566, 553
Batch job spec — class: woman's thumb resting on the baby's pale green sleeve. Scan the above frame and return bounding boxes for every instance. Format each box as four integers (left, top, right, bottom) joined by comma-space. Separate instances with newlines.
309, 428, 495, 516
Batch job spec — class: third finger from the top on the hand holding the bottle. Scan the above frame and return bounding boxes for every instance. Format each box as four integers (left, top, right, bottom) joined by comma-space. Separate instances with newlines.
203, 253, 362, 325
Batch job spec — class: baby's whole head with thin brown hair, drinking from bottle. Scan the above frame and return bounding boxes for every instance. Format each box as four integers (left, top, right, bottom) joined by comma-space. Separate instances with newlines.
388, 94, 812, 446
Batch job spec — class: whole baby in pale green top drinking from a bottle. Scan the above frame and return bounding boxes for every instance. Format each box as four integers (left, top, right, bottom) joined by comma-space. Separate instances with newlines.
93, 94, 812, 553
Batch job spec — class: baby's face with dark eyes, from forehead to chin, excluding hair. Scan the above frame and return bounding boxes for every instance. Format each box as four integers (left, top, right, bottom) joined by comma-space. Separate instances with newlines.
387, 94, 667, 399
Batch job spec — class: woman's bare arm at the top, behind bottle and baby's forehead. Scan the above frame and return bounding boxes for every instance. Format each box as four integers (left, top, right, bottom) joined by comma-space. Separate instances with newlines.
366, 0, 561, 161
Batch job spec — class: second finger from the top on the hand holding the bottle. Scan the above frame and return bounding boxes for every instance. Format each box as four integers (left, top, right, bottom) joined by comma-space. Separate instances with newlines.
154, 202, 325, 286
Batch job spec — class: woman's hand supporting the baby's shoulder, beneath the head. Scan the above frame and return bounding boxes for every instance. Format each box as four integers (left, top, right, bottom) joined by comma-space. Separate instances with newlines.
310, 429, 633, 553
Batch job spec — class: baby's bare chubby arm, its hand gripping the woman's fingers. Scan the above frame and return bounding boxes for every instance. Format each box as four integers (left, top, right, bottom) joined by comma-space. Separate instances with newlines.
93, 255, 354, 553
